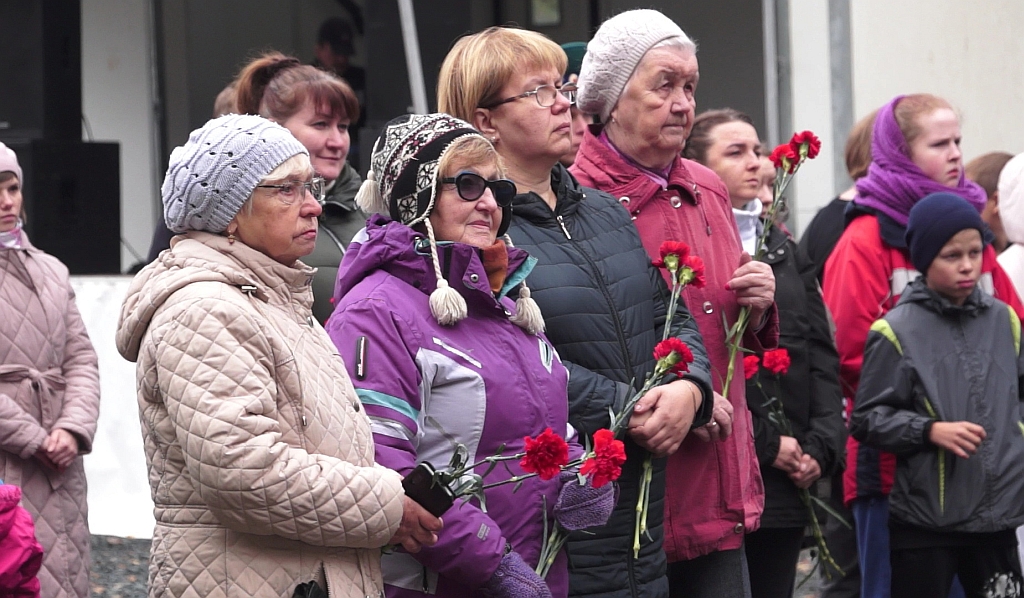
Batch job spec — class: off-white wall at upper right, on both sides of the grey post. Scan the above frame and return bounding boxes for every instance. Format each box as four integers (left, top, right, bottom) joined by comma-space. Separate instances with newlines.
783, 0, 1024, 231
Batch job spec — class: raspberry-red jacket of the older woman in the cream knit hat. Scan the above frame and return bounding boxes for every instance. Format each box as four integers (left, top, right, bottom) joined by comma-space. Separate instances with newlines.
570, 132, 778, 561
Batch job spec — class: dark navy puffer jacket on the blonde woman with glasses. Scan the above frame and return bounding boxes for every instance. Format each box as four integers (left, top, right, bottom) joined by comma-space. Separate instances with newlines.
509, 166, 713, 598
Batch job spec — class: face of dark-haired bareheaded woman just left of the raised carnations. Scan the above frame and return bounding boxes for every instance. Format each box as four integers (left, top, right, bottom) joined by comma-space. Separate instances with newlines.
706, 121, 761, 208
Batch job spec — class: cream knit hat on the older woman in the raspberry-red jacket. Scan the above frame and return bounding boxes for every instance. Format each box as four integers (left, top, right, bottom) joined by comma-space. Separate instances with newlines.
577, 8, 696, 123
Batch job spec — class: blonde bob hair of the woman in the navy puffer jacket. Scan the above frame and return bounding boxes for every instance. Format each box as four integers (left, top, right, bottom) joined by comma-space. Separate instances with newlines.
437, 27, 568, 123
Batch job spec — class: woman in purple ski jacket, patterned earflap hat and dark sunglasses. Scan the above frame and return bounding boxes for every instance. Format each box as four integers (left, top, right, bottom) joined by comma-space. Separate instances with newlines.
327, 114, 614, 598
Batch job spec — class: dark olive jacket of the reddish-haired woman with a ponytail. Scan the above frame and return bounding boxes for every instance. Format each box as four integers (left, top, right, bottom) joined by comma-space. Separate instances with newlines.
302, 164, 367, 324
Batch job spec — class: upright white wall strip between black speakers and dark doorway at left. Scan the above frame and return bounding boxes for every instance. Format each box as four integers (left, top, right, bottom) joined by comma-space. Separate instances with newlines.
82, 0, 155, 271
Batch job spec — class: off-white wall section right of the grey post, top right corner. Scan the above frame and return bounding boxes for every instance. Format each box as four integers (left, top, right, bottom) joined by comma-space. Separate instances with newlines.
850, 0, 1024, 160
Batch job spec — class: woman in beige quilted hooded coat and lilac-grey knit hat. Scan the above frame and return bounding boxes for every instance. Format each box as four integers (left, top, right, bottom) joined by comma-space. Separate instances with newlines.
116, 115, 441, 598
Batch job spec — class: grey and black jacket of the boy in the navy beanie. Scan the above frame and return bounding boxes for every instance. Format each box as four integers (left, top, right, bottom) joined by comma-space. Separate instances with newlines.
850, 276, 1024, 532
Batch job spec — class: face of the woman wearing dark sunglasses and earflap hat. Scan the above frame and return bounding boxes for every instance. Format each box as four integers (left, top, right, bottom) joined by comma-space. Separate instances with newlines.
430, 161, 502, 248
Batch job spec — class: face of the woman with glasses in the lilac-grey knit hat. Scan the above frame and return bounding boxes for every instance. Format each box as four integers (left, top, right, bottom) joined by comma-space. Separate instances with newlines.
227, 166, 323, 265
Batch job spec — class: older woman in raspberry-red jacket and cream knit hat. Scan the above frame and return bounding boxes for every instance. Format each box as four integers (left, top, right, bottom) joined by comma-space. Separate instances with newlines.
570, 10, 778, 596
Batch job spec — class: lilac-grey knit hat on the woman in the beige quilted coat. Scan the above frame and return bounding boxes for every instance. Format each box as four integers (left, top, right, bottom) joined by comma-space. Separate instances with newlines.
160, 115, 309, 232
